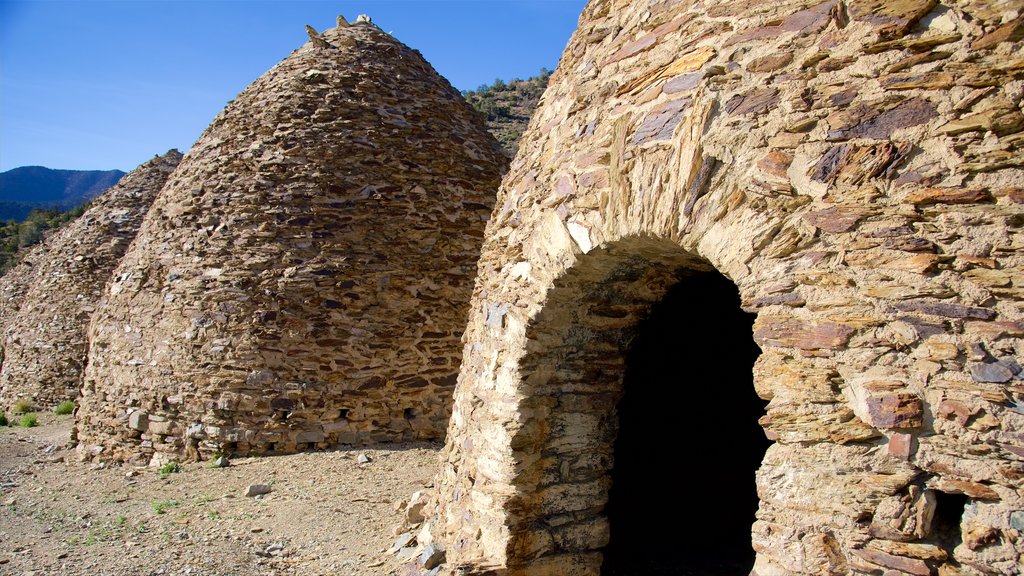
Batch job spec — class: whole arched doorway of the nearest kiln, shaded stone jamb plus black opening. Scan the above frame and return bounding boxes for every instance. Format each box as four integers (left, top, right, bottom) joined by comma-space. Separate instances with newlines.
468, 237, 766, 575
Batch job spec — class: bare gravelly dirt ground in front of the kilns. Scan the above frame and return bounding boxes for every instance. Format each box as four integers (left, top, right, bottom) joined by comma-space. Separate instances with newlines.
0, 414, 439, 576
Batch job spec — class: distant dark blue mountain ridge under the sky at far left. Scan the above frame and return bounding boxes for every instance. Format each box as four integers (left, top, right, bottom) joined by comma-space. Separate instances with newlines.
0, 166, 125, 221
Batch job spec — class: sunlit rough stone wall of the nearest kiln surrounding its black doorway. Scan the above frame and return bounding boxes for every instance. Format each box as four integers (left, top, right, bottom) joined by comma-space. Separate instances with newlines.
432, 0, 1024, 576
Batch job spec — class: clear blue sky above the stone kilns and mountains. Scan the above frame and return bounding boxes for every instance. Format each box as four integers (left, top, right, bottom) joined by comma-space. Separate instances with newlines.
0, 0, 586, 171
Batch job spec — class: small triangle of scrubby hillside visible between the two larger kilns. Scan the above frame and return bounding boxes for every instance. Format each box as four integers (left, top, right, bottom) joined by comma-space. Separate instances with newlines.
462, 68, 551, 156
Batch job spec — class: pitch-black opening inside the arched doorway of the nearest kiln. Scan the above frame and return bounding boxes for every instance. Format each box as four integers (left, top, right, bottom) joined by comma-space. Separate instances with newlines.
601, 273, 769, 576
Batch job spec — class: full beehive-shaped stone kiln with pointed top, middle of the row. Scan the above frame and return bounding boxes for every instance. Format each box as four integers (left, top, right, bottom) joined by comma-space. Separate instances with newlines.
79, 22, 505, 461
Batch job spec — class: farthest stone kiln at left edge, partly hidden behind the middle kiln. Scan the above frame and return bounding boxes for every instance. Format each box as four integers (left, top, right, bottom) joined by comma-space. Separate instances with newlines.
0, 150, 181, 408
